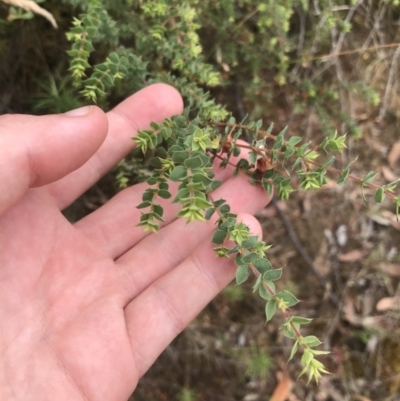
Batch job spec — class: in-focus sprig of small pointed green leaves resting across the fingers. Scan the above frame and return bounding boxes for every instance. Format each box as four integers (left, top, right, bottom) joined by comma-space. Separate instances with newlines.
134, 109, 400, 381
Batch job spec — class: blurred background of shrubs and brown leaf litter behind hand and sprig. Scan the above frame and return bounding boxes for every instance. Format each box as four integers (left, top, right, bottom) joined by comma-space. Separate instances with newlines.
0, 0, 400, 401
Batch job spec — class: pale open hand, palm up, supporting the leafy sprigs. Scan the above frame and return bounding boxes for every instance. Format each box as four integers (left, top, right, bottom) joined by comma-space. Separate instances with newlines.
0, 84, 269, 401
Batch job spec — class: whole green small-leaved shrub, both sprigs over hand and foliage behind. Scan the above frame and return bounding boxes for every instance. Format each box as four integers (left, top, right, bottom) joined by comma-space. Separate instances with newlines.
3, 0, 400, 380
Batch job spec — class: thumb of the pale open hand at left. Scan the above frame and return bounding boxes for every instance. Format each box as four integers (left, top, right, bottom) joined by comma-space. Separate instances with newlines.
0, 106, 108, 215
